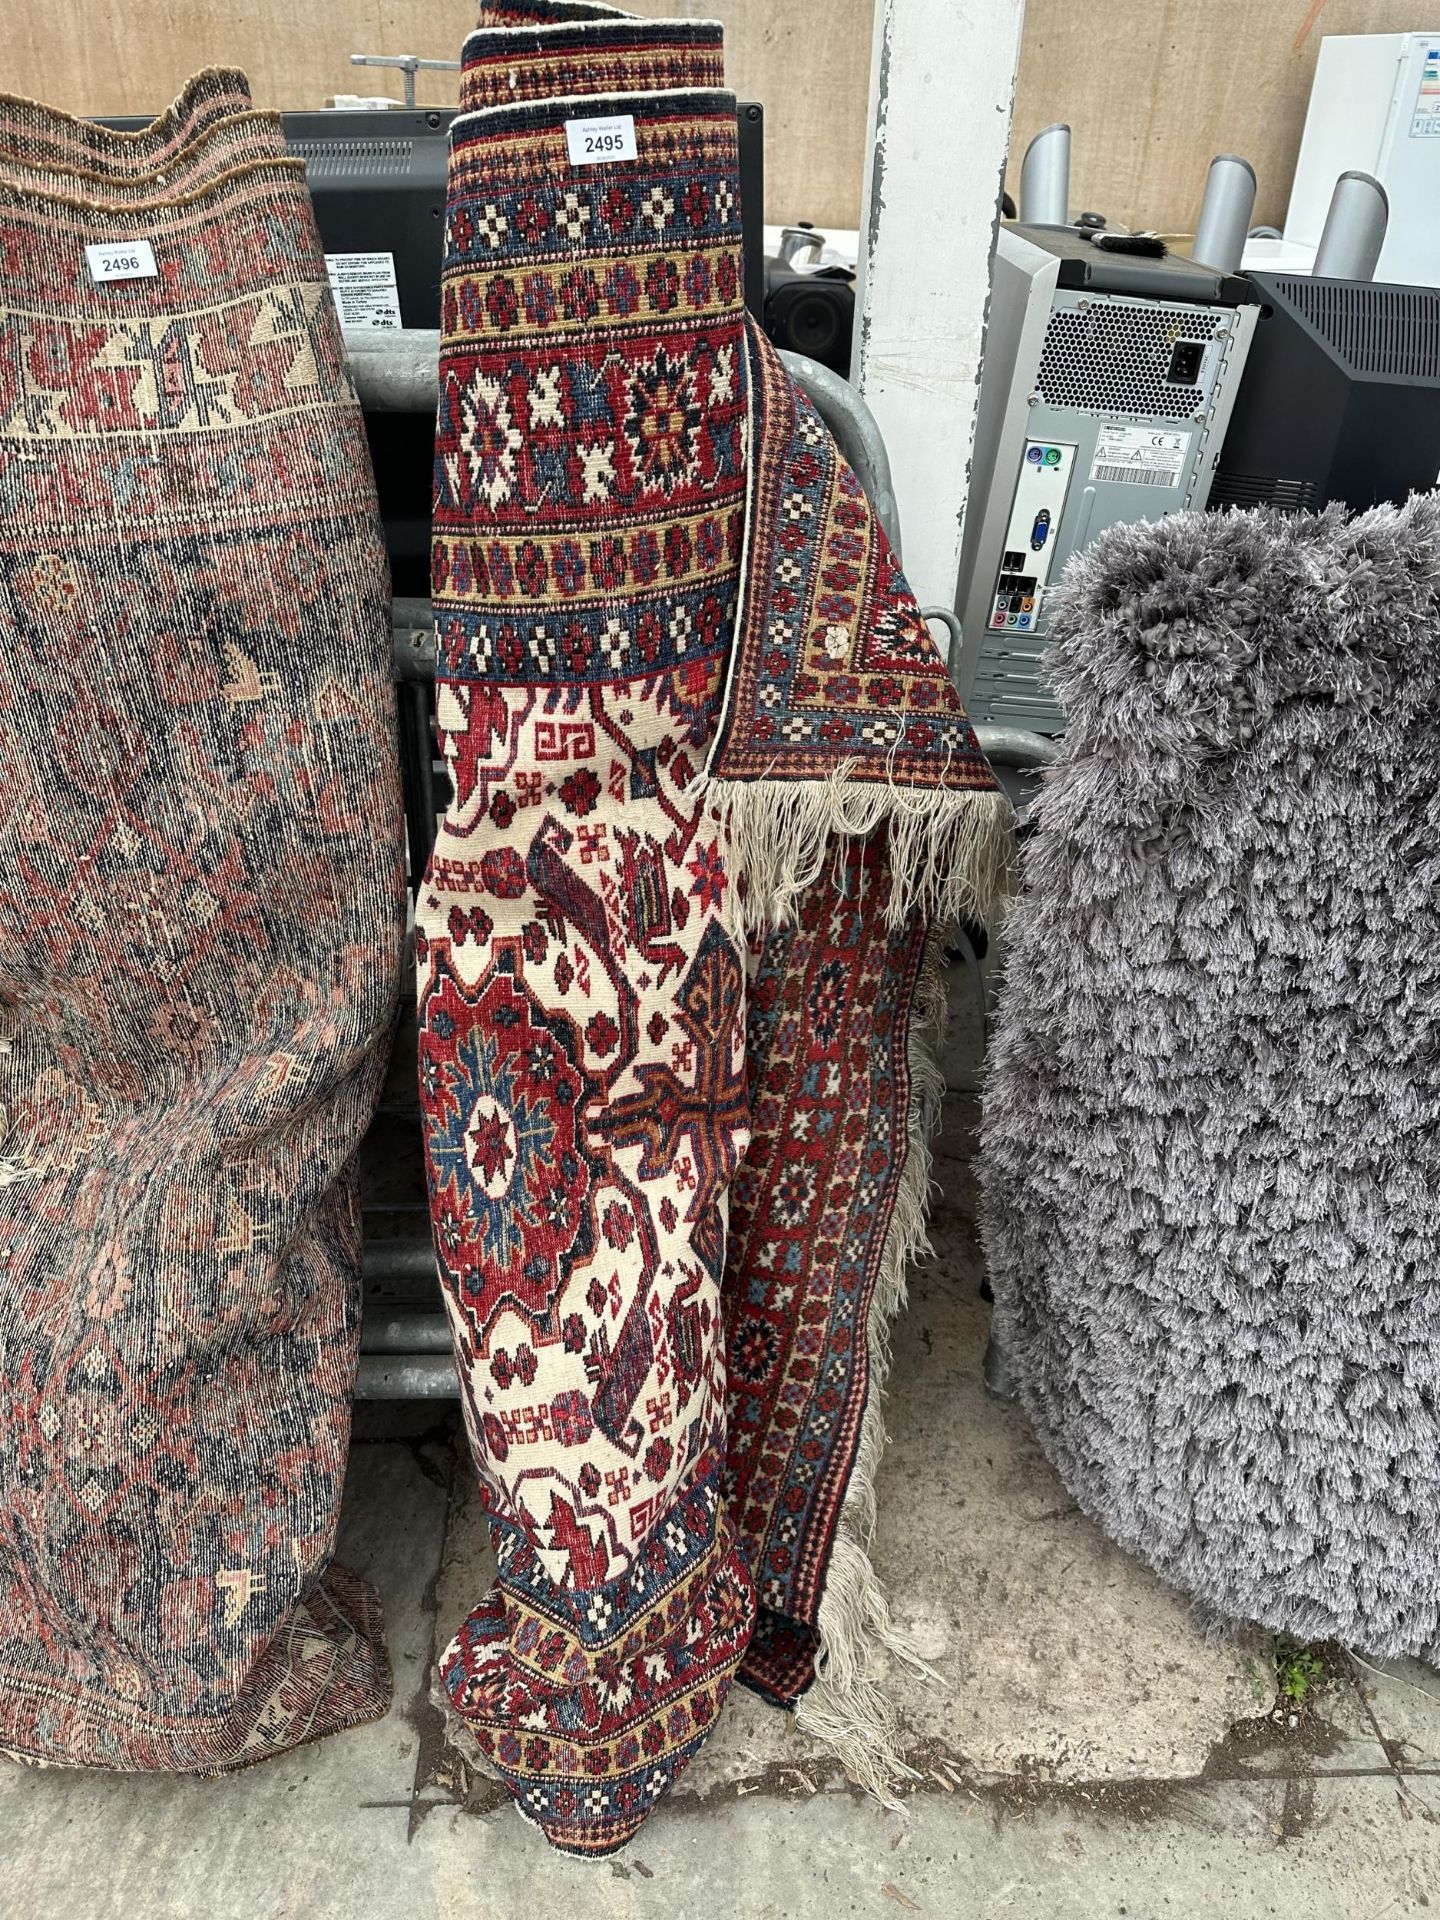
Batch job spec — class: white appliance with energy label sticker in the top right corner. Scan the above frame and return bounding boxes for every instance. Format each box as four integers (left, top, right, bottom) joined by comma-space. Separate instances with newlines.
1290, 27, 1440, 286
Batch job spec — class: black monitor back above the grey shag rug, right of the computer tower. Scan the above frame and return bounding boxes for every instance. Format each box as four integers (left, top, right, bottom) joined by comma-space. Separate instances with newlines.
1210, 273, 1440, 511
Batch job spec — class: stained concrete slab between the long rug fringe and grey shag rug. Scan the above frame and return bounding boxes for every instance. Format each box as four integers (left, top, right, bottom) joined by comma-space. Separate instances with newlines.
856, 1198, 1269, 1780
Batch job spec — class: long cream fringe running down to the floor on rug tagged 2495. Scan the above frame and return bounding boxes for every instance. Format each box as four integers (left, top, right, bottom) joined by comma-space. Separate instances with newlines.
795, 929, 960, 1807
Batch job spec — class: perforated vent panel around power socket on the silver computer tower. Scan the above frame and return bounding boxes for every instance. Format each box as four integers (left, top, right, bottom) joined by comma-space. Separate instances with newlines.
1037, 300, 1223, 420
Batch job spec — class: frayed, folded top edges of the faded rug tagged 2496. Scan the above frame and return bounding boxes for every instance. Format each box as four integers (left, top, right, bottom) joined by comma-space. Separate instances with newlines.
0, 67, 259, 179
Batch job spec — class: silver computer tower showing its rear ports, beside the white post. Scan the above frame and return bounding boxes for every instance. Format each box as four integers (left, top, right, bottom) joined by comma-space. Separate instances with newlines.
958, 227, 1256, 733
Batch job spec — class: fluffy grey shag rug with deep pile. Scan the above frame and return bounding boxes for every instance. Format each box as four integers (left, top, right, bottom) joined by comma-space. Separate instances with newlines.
981, 495, 1440, 1655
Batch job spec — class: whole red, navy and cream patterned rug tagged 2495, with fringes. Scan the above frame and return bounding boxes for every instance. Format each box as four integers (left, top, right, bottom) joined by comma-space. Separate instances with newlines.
419, 4, 1008, 1855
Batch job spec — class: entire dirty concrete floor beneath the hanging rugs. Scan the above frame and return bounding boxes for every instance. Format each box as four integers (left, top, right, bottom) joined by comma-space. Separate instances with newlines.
0, 975, 1440, 1920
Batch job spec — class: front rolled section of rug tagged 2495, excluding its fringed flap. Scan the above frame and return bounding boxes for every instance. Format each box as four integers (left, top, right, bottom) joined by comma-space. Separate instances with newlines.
419, 48, 753, 1853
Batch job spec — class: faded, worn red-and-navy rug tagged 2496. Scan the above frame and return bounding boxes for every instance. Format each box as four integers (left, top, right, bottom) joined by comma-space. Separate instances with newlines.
0, 90, 403, 1772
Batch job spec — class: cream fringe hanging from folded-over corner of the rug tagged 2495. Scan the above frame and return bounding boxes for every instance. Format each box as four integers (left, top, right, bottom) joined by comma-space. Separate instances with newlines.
703, 760, 1014, 939
